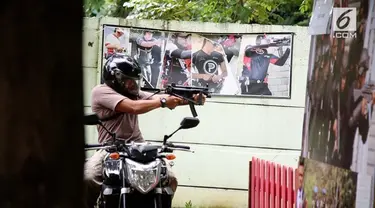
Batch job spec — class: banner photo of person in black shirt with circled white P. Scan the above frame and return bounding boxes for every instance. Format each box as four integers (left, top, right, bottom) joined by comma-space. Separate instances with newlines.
191, 34, 241, 95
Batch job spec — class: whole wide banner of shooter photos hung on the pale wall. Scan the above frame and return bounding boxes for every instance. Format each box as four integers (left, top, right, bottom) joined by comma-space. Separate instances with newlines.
102, 25, 293, 98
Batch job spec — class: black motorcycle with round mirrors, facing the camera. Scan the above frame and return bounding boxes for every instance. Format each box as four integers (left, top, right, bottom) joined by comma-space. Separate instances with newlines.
84, 114, 200, 208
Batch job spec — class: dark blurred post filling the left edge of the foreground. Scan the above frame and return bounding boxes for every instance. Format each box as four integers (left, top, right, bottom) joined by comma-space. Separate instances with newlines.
0, 0, 85, 208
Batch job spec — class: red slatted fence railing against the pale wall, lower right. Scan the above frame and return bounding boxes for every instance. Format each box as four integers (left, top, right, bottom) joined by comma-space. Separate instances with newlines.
248, 157, 296, 208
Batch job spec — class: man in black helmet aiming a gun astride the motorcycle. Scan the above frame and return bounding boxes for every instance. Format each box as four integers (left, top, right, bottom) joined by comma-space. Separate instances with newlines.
84, 54, 205, 208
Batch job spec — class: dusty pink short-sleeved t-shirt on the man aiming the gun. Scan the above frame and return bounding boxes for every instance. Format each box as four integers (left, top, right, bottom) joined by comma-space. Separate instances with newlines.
91, 84, 147, 143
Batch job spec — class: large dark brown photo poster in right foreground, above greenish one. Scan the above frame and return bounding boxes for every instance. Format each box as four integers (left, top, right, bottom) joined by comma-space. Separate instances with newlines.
303, 0, 375, 175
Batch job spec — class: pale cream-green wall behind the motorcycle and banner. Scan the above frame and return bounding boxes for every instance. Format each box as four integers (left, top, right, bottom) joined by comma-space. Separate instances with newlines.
83, 18, 310, 208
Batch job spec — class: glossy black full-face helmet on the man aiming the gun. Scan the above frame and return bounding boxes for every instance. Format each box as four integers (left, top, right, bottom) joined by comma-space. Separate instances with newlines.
103, 54, 142, 99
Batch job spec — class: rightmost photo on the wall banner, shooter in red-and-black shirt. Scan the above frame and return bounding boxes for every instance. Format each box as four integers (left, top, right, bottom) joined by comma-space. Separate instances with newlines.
236, 34, 293, 97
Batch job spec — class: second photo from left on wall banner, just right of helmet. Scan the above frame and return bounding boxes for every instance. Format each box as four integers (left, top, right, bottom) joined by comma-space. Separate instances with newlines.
129, 29, 167, 88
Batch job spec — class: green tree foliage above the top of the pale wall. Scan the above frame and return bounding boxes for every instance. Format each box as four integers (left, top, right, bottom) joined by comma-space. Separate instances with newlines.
85, 0, 312, 25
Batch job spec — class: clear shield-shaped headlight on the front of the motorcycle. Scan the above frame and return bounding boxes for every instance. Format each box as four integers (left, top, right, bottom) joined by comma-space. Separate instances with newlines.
125, 159, 161, 194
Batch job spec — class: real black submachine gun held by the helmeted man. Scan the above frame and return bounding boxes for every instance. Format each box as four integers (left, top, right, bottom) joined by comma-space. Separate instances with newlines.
141, 83, 211, 117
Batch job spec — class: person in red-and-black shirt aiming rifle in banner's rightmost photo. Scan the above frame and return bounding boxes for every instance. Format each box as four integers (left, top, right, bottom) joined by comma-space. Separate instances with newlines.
239, 35, 290, 95
